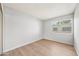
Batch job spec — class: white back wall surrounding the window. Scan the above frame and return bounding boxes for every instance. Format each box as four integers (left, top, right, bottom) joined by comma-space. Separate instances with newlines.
43, 14, 73, 45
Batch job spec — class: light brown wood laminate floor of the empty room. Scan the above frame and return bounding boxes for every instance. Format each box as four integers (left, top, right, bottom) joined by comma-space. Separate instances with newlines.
4, 39, 77, 56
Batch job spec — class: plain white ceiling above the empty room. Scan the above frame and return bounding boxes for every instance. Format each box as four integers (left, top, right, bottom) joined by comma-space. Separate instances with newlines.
3, 3, 76, 20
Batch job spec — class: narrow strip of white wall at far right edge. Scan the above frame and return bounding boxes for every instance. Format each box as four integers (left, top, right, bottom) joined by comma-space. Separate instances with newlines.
74, 4, 79, 55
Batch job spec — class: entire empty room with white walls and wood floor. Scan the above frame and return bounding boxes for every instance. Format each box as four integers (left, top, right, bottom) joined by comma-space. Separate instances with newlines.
0, 3, 79, 56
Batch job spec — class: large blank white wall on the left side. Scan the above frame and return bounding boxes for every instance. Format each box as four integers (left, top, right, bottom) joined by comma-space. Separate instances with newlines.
3, 6, 42, 51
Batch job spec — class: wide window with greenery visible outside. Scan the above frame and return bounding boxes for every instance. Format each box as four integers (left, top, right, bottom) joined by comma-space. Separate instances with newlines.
53, 20, 72, 32
